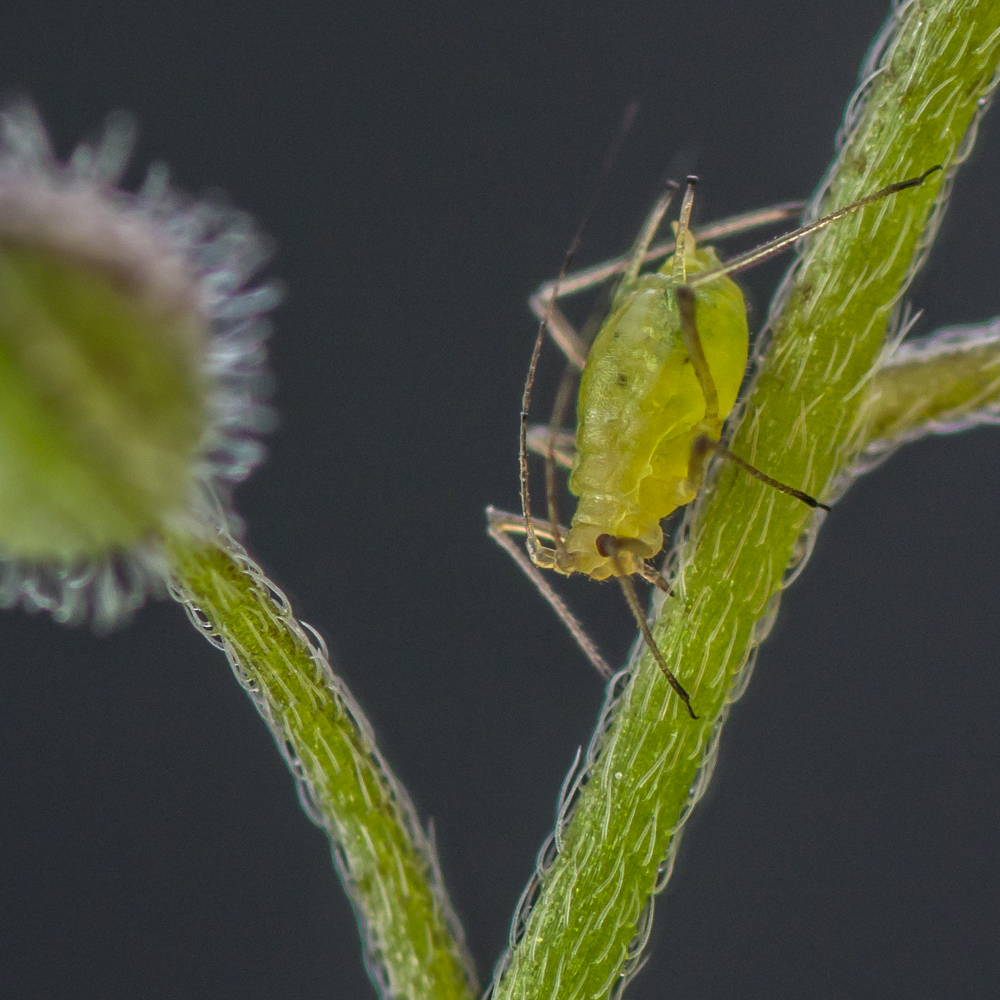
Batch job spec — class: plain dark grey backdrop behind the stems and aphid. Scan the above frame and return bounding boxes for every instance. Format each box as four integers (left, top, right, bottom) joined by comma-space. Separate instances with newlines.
0, 0, 1000, 1000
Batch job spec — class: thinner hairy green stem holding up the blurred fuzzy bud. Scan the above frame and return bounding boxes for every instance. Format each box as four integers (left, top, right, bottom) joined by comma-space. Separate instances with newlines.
165, 534, 477, 1000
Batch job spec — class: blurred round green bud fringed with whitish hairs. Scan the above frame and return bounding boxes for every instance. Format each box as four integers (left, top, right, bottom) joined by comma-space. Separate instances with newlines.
0, 104, 278, 629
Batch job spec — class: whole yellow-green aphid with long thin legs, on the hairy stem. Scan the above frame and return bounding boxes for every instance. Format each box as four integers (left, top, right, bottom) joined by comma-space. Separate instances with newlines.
490, 167, 940, 718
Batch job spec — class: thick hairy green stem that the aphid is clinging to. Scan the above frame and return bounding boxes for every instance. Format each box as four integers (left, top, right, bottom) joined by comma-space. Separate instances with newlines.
494, 0, 1000, 1000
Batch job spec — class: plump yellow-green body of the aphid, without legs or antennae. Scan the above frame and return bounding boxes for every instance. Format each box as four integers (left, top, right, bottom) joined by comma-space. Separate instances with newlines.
565, 248, 748, 579
